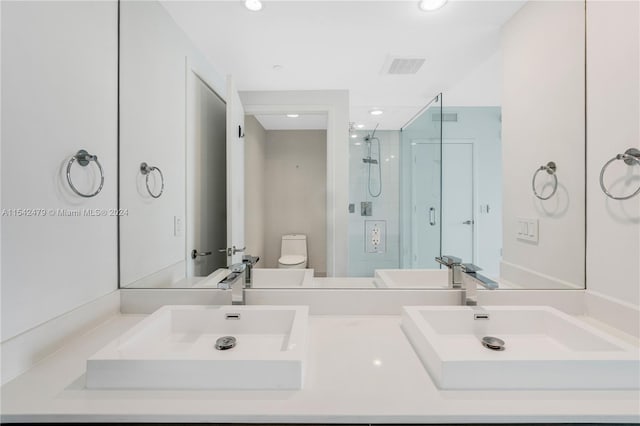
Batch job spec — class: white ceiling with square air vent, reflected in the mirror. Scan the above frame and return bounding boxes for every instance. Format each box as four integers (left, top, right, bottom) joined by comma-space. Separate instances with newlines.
162, 0, 525, 129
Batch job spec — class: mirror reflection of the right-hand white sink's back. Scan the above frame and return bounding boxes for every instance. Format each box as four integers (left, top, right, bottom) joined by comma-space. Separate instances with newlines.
373, 269, 449, 288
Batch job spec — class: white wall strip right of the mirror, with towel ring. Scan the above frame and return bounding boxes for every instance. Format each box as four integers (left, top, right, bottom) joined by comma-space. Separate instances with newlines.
587, 1, 640, 307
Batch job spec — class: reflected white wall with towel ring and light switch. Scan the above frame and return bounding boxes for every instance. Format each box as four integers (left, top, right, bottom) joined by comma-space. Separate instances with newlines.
501, 2, 585, 287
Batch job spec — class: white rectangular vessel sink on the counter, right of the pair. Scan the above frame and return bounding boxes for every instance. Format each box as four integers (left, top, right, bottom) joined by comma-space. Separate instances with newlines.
402, 306, 640, 389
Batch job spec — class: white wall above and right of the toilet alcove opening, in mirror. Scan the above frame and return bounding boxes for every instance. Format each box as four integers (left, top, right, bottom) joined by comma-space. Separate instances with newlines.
240, 90, 349, 276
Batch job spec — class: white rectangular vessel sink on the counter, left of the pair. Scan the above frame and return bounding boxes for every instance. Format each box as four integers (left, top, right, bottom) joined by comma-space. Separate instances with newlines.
86, 305, 308, 389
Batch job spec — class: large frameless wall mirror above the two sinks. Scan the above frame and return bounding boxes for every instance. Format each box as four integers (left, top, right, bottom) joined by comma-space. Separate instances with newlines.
119, 0, 586, 289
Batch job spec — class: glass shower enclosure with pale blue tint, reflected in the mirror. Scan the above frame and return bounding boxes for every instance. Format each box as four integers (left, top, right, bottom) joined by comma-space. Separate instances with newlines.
349, 94, 502, 277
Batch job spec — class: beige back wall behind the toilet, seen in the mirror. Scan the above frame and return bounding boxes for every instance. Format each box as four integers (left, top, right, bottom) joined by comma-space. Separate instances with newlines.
264, 130, 327, 276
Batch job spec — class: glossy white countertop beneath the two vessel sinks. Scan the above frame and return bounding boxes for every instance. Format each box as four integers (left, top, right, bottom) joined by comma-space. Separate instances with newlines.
1, 315, 640, 423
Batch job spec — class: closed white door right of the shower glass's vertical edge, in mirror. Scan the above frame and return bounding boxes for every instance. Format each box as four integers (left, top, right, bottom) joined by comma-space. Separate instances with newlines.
442, 140, 475, 263
